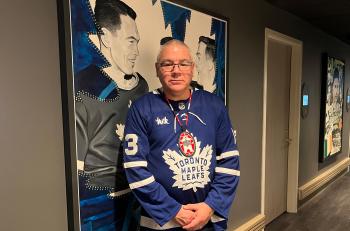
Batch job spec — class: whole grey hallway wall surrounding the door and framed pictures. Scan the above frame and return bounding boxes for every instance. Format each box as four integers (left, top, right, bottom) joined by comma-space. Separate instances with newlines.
0, 0, 350, 231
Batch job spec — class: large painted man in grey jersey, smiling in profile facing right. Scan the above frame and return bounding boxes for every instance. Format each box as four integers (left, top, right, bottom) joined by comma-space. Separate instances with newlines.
74, 0, 148, 230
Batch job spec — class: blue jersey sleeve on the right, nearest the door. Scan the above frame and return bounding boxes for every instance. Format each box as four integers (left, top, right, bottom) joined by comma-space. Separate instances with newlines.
205, 105, 240, 219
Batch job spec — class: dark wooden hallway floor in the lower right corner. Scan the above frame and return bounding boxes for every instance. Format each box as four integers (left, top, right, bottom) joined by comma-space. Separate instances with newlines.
265, 173, 350, 231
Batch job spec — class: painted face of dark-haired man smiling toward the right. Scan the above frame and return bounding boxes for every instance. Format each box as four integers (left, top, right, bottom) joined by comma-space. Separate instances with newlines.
110, 15, 140, 75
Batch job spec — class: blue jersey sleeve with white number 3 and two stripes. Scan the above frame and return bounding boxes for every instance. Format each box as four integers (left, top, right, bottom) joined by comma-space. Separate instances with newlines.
124, 104, 181, 226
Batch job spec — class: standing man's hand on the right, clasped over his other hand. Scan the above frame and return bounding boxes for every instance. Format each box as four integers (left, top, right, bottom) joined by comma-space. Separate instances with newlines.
182, 202, 214, 231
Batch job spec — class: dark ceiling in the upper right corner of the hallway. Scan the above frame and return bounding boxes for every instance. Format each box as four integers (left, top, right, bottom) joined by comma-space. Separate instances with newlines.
266, 0, 350, 44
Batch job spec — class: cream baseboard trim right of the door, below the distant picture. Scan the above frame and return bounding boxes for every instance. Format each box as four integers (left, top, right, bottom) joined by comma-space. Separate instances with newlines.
298, 158, 350, 200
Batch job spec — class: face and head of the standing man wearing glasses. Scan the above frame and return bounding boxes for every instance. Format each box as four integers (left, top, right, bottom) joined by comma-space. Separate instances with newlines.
156, 43, 194, 95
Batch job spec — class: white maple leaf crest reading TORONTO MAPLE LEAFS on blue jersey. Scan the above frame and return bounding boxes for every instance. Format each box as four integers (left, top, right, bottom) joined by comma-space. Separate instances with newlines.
163, 137, 213, 192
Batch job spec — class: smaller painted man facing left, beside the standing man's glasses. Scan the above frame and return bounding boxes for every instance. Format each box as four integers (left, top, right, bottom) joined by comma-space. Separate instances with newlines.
196, 36, 216, 92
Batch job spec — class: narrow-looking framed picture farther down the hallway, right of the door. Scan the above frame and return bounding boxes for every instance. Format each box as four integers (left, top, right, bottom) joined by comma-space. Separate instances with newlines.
319, 54, 345, 162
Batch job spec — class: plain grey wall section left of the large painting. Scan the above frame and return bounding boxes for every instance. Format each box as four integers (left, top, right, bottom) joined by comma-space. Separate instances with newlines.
0, 0, 67, 231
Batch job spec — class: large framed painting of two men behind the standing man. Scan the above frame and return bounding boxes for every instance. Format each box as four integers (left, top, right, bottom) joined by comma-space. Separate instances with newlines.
58, 0, 228, 231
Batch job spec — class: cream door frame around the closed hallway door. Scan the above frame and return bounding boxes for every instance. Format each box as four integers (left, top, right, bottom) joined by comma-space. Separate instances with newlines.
261, 28, 303, 214
